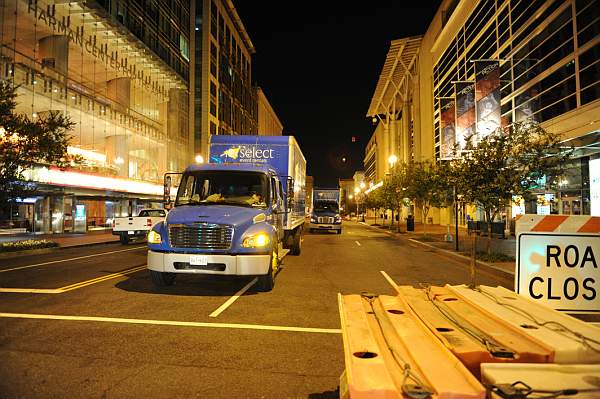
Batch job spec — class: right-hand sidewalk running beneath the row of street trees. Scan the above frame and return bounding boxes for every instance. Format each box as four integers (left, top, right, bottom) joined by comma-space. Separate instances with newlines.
358, 218, 516, 276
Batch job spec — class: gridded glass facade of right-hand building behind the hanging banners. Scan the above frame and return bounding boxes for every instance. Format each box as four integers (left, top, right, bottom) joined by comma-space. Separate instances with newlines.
433, 0, 600, 215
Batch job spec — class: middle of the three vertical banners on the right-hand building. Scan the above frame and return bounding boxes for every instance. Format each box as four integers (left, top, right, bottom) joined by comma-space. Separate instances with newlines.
454, 82, 477, 151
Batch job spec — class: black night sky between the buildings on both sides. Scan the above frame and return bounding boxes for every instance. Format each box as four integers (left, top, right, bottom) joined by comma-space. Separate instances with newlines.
234, 0, 440, 187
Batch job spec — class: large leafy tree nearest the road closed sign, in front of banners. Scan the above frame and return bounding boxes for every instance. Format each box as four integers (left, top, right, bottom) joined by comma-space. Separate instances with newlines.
452, 122, 571, 253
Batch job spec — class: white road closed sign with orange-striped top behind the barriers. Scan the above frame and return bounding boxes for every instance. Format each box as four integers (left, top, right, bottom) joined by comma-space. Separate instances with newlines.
515, 215, 600, 313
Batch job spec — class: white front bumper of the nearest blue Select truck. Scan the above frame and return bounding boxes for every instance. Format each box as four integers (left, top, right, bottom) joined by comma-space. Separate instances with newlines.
148, 251, 271, 276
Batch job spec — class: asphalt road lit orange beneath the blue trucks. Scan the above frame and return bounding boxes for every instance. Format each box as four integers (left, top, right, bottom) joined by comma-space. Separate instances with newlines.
0, 223, 512, 399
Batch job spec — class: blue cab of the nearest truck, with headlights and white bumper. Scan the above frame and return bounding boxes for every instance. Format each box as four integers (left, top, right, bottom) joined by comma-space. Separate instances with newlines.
148, 164, 299, 291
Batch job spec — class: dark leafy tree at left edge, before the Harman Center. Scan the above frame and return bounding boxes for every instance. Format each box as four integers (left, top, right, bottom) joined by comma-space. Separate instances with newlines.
0, 81, 79, 216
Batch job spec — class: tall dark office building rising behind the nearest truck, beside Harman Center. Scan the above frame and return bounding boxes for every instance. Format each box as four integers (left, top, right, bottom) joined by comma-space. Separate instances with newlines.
194, 0, 258, 160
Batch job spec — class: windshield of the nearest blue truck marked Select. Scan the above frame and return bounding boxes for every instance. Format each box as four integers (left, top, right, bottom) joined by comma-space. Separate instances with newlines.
175, 171, 269, 208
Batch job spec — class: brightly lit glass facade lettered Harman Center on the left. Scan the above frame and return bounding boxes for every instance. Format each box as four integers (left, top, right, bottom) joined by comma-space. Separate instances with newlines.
0, 0, 193, 232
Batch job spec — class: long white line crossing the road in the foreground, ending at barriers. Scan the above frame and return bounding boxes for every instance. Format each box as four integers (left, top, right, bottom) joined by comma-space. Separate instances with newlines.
0, 313, 342, 334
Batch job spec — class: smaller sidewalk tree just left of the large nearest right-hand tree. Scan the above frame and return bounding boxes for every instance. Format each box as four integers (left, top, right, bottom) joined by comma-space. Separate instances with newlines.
406, 161, 452, 234
